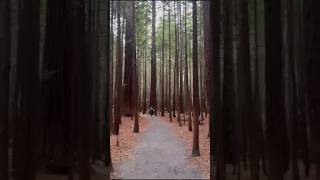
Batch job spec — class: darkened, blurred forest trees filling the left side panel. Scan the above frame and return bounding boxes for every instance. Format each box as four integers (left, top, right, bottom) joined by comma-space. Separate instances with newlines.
0, 0, 110, 180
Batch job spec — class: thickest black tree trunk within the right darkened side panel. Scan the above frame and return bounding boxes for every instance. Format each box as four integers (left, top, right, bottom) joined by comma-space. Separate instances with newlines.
265, 0, 288, 180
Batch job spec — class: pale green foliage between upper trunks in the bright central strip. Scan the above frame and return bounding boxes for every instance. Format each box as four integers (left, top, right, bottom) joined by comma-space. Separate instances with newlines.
113, 1, 203, 69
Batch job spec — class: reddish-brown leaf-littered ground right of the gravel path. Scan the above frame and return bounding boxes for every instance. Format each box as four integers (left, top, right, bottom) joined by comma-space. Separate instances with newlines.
161, 114, 210, 179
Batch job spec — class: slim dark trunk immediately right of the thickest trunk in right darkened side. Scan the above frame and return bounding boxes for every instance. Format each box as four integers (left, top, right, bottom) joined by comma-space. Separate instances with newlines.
283, 1, 299, 180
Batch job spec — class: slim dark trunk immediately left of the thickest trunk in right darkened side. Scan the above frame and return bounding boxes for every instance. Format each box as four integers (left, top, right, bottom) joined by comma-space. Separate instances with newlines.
239, 0, 259, 180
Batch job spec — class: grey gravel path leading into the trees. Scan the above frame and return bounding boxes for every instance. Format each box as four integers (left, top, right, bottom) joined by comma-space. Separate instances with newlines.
118, 117, 201, 179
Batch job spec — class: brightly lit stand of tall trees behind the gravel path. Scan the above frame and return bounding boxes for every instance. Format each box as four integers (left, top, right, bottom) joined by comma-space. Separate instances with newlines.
110, 1, 210, 156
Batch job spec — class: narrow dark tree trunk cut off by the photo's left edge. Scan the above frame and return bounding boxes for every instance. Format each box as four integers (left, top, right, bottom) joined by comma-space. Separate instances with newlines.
0, 0, 11, 180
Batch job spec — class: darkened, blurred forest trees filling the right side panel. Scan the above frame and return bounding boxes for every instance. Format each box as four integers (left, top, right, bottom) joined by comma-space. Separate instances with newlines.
208, 0, 320, 180
